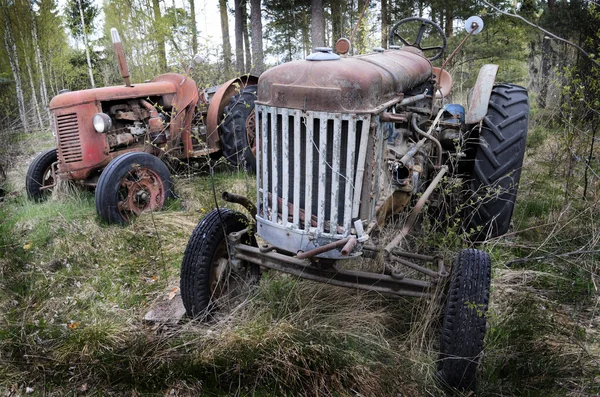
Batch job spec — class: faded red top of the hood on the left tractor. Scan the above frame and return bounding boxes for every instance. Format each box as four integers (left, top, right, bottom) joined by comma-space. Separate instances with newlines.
49, 73, 189, 110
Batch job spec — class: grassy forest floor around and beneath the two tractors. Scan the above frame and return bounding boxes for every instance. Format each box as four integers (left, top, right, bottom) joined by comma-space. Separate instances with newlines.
0, 129, 600, 396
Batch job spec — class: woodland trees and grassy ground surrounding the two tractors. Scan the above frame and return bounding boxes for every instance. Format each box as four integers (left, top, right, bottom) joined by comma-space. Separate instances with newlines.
0, 0, 600, 396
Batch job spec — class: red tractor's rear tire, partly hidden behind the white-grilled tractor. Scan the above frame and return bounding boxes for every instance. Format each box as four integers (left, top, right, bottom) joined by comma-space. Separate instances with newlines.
219, 85, 257, 172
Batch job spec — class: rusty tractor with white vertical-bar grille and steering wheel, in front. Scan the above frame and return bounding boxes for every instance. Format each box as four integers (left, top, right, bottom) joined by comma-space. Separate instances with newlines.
181, 17, 529, 389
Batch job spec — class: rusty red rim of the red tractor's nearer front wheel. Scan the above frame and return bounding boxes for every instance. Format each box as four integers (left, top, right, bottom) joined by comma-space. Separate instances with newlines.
117, 167, 165, 220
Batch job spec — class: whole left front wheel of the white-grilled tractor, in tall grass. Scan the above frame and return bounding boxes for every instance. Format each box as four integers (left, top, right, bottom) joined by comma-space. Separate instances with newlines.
180, 208, 260, 317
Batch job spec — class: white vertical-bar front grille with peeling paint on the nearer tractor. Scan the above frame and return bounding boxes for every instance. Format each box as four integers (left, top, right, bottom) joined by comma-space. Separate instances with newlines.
256, 105, 370, 241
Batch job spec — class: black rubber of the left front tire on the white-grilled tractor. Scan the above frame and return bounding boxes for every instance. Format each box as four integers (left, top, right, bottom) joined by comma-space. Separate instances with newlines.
180, 208, 260, 317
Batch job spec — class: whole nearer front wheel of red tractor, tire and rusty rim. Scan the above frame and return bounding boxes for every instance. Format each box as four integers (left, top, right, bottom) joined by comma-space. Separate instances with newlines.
96, 152, 173, 225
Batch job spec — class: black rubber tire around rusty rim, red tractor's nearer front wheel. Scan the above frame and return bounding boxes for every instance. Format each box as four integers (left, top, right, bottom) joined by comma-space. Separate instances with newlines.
96, 152, 173, 225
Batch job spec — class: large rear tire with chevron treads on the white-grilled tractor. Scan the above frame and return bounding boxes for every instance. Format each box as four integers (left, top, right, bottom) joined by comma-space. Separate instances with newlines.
466, 84, 529, 241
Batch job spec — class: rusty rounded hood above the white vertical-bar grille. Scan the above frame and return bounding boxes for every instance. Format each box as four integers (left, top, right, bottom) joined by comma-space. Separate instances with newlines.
256, 50, 432, 113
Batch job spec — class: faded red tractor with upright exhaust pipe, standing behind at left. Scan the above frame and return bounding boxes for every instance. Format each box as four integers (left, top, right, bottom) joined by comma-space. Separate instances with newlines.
26, 29, 258, 224
